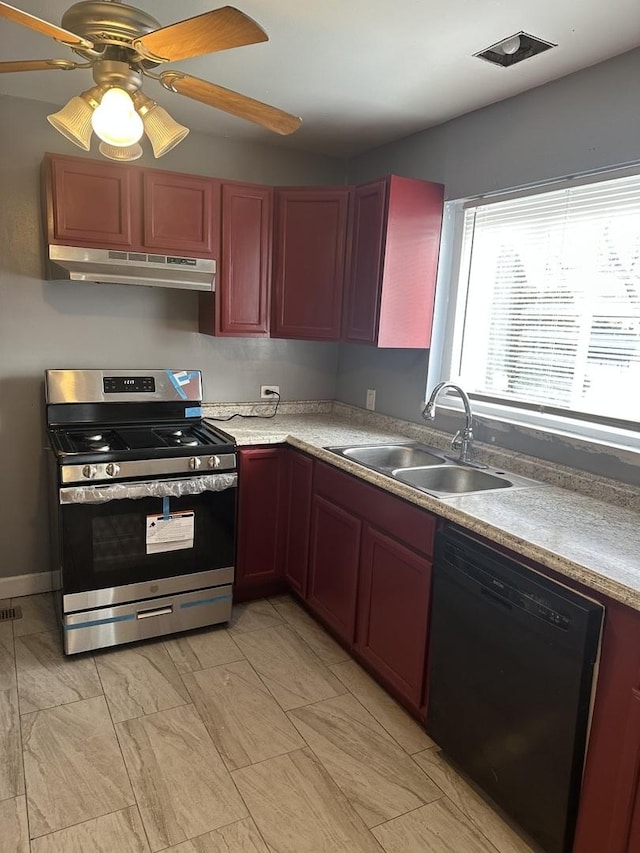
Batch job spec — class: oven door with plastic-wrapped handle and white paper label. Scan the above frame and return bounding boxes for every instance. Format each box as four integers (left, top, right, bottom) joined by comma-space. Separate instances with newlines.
58, 473, 237, 613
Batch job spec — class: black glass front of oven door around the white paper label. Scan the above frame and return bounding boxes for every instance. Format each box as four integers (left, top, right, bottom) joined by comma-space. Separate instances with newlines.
61, 489, 236, 593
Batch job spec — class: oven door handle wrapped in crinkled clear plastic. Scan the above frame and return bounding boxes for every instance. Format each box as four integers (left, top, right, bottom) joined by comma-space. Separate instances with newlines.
58, 472, 238, 504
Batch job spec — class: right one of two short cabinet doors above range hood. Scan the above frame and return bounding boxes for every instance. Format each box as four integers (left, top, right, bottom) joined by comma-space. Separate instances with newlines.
142, 169, 219, 258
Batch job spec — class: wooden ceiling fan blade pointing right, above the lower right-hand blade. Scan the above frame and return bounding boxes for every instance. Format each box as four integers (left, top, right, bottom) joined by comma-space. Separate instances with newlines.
132, 6, 269, 62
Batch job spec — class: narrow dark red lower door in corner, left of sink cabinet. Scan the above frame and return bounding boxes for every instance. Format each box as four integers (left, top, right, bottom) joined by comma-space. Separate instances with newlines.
284, 450, 313, 598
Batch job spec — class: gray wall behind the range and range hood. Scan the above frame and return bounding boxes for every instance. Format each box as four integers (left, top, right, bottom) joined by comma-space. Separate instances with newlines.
0, 97, 345, 577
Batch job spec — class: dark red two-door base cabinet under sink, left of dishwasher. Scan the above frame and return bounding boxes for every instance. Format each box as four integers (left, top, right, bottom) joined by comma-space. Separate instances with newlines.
306, 462, 436, 717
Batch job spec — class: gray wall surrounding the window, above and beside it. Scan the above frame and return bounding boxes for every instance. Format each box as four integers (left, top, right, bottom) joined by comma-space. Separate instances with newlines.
337, 49, 640, 482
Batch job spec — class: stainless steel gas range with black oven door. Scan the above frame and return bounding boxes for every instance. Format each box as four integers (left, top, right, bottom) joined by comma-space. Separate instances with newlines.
45, 370, 237, 654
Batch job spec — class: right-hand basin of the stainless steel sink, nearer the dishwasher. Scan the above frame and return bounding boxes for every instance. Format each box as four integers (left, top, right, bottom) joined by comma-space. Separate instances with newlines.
392, 464, 542, 498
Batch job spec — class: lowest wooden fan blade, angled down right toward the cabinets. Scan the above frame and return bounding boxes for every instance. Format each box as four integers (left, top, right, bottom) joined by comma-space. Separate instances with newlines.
160, 71, 302, 136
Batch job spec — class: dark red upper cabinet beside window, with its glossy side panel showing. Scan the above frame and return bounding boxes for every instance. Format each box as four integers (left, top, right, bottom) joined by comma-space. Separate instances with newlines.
343, 175, 444, 349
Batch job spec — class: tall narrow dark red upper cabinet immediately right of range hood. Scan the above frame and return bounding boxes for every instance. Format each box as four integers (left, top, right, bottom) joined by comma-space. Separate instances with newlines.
200, 183, 273, 338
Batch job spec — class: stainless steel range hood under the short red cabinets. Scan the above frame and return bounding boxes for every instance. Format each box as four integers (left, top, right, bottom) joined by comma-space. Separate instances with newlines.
47, 245, 216, 291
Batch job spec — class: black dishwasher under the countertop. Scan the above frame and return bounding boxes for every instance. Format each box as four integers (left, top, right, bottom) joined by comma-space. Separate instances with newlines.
427, 528, 604, 853
